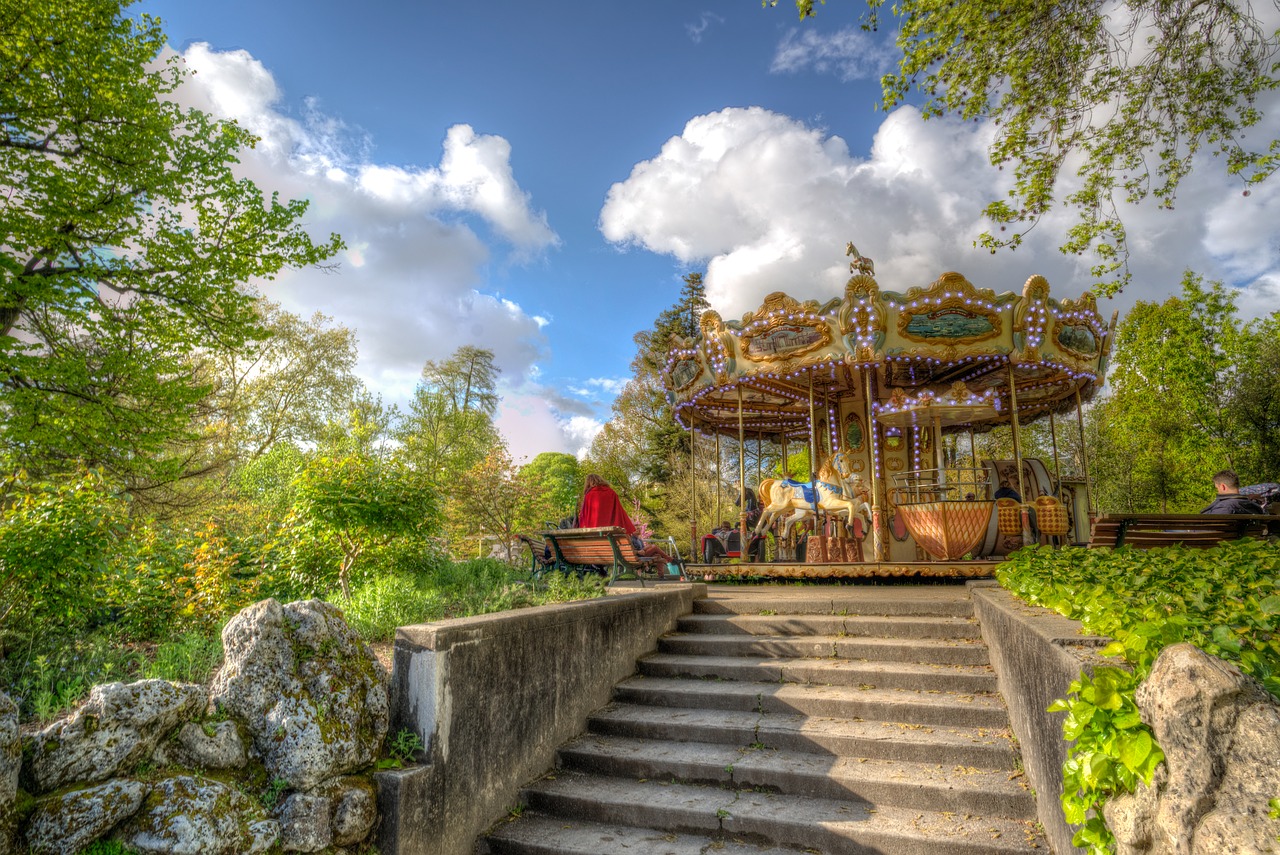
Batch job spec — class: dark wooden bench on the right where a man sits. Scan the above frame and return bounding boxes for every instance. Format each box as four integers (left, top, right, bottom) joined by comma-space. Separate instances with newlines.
1089, 513, 1280, 549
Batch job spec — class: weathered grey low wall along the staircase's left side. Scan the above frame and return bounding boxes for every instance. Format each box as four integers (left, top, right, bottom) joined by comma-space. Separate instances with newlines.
378, 585, 707, 855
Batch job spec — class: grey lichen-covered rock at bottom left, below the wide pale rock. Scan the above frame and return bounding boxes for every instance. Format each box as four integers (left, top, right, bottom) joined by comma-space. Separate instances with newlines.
27, 778, 150, 855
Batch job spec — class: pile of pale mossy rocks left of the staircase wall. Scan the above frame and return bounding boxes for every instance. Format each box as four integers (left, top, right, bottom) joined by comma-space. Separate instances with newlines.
0, 600, 388, 855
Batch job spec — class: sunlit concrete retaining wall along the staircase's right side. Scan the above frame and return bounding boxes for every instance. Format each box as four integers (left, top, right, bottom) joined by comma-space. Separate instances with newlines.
969, 581, 1114, 855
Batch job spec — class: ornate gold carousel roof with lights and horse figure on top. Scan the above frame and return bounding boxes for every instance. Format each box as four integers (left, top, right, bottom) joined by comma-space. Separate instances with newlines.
664, 261, 1116, 438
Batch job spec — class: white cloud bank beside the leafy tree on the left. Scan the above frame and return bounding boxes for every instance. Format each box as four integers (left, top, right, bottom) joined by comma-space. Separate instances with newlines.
171, 44, 567, 427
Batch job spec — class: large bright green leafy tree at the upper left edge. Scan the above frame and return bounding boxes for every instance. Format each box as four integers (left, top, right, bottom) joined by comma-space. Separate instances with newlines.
0, 0, 342, 490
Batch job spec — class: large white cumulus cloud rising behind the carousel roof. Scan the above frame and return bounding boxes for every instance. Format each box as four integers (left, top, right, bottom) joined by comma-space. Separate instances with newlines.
600, 108, 1280, 323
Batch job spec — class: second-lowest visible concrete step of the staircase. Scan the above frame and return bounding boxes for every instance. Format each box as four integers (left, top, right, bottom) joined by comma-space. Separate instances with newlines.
495, 772, 1047, 855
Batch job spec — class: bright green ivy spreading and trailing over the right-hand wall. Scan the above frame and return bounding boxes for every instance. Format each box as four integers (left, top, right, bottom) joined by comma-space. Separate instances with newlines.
996, 540, 1280, 855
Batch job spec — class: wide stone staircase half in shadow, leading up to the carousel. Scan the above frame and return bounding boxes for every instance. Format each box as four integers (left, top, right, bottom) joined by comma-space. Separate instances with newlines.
479, 586, 1048, 855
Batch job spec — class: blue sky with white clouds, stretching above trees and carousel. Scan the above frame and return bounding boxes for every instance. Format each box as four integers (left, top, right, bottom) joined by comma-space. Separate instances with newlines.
134, 0, 1280, 458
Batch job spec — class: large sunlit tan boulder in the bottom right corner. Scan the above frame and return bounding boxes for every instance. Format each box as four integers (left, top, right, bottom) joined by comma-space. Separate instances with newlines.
1105, 644, 1280, 855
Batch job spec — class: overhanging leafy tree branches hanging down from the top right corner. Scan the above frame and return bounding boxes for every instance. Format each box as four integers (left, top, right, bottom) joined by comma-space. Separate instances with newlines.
768, 0, 1280, 293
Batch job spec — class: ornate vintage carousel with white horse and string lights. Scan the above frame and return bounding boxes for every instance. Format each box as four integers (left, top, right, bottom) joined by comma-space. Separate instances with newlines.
664, 243, 1116, 579
